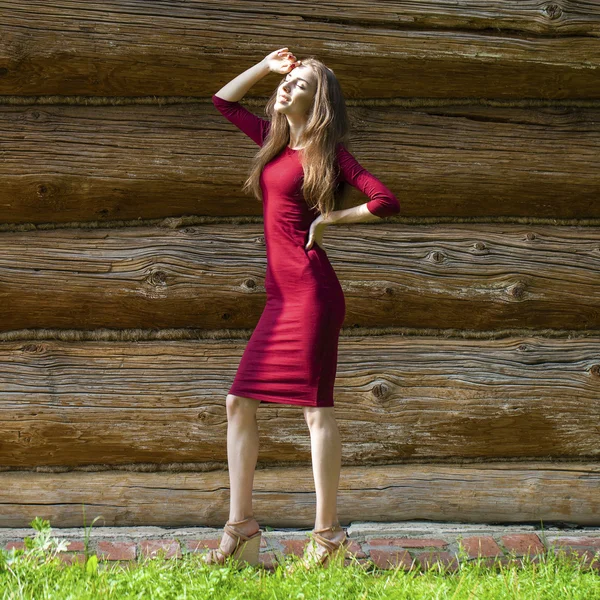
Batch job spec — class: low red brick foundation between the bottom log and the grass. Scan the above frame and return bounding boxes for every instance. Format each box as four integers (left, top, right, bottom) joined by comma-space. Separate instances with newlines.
0, 523, 600, 573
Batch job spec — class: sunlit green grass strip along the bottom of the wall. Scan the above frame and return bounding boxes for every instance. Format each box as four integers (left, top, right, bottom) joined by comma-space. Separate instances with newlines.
0, 520, 600, 600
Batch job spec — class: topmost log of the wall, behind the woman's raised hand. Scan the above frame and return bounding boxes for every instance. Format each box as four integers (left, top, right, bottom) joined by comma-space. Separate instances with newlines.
0, 0, 600, 99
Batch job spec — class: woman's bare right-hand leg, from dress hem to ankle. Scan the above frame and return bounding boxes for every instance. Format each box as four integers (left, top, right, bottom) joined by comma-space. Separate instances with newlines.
304, 406, 344, 541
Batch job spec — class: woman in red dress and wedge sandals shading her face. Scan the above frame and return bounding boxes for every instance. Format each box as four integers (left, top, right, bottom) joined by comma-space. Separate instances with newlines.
204, 48, 400, 566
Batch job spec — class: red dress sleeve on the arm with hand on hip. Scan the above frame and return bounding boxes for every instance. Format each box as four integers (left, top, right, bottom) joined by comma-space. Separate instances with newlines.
337, 144, 400, 218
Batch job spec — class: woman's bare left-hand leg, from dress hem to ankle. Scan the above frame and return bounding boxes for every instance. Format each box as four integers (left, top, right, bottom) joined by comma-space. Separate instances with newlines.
225, 394, 260, 539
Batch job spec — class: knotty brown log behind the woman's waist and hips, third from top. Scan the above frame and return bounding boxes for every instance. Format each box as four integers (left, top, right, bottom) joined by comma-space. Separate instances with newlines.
0, 224, 600, 331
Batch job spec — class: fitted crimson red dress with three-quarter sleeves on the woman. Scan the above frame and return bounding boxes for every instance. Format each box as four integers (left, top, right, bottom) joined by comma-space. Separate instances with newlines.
212, 95, 400, 406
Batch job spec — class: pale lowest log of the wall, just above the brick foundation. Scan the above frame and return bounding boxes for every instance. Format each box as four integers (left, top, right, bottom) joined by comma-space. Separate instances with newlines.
0, 462, 600, 527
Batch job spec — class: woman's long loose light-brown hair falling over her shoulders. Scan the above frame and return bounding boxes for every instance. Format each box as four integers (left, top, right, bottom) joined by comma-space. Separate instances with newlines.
242, 56, 349, 216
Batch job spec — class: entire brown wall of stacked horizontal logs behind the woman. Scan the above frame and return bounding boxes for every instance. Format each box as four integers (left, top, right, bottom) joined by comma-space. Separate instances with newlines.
0, 0, 600, 527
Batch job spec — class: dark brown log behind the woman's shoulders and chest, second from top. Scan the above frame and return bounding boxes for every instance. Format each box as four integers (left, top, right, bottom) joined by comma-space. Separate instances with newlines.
0, 101, 600, 224
